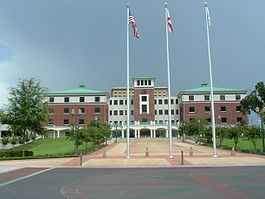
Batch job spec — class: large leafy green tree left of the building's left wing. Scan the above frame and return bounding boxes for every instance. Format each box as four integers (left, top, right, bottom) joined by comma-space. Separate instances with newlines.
6, 78, 48, 154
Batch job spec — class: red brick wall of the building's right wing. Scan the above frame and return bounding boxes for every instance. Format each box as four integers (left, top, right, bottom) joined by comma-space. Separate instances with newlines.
179, 102, 248, 124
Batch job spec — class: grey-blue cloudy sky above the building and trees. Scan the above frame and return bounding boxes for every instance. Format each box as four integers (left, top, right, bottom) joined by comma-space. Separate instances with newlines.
0, 0, 265, 119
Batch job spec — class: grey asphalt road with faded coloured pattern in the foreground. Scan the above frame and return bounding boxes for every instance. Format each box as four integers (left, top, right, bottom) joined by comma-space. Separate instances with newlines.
0, 167, 265, 199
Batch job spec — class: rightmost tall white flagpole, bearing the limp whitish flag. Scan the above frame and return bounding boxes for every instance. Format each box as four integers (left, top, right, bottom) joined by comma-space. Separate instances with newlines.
204, 2, 217, 158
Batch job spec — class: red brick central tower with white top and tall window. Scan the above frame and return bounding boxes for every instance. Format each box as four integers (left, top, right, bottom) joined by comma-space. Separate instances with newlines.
133, 77, 155, 122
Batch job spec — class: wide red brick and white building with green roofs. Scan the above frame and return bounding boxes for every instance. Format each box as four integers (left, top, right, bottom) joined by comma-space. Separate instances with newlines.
43, 77, 247, 138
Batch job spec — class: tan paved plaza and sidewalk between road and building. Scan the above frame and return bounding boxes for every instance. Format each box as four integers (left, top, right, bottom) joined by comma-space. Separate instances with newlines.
0, 139, 265, 168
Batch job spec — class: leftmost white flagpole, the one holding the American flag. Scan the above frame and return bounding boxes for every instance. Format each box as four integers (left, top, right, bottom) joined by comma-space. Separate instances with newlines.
126, 4, 130, 159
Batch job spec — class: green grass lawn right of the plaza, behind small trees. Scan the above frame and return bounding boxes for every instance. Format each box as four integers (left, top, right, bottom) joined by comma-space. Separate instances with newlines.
216, 138, 262, 153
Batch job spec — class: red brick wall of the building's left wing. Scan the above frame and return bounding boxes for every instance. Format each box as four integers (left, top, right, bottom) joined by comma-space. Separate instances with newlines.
49, 104, 108, 126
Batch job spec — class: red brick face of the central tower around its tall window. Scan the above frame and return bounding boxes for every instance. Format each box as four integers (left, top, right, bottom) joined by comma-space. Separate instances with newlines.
134, 88, 155, 122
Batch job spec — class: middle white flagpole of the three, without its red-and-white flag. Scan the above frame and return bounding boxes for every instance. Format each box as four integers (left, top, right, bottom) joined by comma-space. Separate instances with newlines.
165, 3, 173, 158
